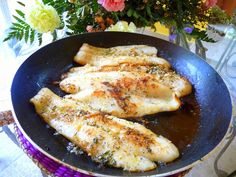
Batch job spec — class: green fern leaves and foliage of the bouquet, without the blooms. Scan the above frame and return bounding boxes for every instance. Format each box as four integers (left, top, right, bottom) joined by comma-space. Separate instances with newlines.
4, 0, 229, 44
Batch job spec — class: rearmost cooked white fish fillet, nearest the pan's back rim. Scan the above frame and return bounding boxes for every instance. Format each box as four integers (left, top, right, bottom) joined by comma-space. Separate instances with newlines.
74, 43, 170, 68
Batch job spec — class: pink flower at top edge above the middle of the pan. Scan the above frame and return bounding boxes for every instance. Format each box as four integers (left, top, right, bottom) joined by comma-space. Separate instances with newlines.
98, 0, 125, 12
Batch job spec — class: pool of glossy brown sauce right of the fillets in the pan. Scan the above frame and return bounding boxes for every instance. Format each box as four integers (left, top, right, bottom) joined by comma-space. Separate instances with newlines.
131, 93, 200, 152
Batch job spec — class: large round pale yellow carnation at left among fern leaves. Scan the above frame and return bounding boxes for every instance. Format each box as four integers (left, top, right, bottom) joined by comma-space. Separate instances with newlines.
26, 1, 60, 33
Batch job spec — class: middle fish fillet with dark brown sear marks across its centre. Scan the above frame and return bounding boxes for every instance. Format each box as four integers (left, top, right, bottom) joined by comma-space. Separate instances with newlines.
60, 71, 180, 118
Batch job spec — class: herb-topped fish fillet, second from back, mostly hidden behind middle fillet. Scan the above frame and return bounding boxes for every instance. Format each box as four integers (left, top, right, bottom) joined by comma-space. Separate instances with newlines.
62, 63, 192, 97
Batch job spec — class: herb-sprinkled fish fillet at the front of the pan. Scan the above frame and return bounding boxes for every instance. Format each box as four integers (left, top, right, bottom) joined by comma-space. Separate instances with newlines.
30, 88, 179, 171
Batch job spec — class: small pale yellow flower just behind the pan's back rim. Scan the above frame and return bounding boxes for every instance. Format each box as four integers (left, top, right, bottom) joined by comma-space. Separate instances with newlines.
106, 21, 136, 32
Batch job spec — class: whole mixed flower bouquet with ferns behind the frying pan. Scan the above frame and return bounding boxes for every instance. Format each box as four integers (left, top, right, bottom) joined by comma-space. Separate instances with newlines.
5, 0, 232, 57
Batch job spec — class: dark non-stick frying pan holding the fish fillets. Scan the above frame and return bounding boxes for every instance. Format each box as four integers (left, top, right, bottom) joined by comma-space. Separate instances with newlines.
11, 32, 232, 176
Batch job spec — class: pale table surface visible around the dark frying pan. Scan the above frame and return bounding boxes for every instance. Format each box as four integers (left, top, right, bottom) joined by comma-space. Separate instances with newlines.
0, 27, 236, 177
